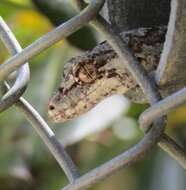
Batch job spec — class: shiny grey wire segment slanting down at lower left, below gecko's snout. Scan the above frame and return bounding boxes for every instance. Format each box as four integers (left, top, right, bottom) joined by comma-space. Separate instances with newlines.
16, 98, 79, 183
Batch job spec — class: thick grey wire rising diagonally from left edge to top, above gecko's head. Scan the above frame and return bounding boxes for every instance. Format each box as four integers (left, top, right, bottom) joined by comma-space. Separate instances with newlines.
0, 0, 104, 81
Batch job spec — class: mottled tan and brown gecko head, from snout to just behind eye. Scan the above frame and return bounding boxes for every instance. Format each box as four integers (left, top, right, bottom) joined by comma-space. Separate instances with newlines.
48, 43, 119, 123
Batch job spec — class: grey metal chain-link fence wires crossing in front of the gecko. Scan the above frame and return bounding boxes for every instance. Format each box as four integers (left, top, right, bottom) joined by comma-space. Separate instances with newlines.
0, 0, 186, 190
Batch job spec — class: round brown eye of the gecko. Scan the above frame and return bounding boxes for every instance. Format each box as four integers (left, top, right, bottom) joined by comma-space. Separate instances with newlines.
76, 64, 97, 83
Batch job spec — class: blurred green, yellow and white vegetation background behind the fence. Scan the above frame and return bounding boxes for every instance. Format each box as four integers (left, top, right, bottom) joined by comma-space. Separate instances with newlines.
0, 0, 186, 190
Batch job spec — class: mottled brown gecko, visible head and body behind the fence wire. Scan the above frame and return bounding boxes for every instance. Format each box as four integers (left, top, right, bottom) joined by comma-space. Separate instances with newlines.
48, 27, 166, 122
